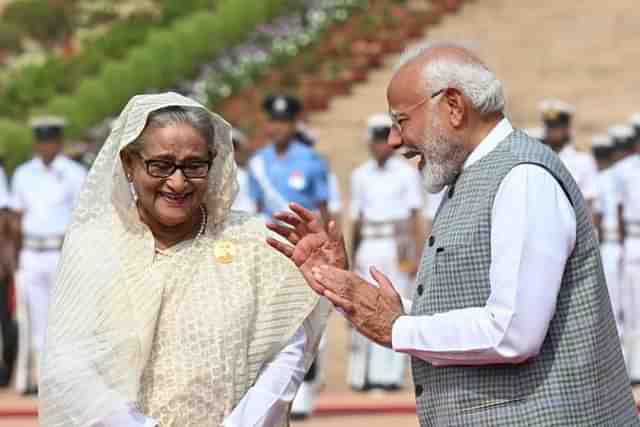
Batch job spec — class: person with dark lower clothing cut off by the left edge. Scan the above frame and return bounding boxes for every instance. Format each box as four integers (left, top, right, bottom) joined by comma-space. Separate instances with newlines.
0, 161, 17, 387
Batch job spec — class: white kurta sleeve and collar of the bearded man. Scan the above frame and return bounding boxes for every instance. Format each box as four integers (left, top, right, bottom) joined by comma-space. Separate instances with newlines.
392, 119, 576, 366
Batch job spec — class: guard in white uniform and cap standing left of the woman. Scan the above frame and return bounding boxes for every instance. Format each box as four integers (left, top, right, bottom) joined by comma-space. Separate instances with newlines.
11, 117, 86, 394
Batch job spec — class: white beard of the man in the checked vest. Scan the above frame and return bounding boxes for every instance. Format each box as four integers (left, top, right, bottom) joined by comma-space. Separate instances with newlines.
420, 123, 468, 194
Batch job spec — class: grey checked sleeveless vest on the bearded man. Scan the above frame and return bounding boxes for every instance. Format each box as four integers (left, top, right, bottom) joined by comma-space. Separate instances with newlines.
412, 131, 640, 427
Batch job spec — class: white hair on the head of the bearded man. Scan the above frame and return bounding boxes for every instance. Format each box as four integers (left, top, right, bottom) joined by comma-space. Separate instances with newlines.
395, 43, 505, 115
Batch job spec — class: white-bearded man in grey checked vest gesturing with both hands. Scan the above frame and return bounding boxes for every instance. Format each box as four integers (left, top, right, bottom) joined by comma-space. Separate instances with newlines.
269, 45, 640, 427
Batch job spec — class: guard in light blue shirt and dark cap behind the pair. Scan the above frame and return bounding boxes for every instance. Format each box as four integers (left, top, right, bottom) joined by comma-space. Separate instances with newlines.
249, 95, 330, 418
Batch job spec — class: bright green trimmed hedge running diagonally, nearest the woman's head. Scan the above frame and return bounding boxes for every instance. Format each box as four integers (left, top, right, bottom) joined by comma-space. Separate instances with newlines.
0, 0, 288, 171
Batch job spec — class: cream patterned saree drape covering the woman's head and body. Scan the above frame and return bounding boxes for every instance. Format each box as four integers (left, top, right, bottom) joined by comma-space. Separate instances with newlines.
40, 93, 328, 427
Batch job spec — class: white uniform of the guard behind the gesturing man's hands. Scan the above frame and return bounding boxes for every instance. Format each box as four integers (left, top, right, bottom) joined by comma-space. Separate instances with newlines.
348, 157, 423, 389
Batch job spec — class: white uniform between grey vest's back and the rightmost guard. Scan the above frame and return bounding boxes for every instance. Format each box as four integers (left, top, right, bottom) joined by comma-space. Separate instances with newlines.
594, 167, 622, 334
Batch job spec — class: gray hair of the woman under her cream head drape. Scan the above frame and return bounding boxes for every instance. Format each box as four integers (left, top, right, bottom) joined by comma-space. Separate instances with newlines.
129, 106, 216, 153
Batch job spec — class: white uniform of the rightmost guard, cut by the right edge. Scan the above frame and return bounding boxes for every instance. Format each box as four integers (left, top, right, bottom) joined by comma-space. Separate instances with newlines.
614, 154, 640, 381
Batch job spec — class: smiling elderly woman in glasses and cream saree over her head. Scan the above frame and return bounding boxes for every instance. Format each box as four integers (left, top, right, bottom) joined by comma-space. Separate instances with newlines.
40, 93, 328, 427
